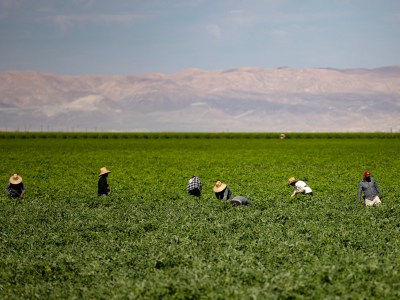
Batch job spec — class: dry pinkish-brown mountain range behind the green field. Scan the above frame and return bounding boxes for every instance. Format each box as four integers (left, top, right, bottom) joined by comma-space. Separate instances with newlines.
0, 66, 400, 132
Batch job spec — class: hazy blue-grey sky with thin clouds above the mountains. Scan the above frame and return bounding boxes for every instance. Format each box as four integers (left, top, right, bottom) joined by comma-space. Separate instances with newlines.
0, 0, 400, 75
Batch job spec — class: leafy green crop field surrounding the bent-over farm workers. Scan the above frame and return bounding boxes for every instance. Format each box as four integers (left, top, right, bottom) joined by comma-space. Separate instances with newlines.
0, 133, 400, 299
